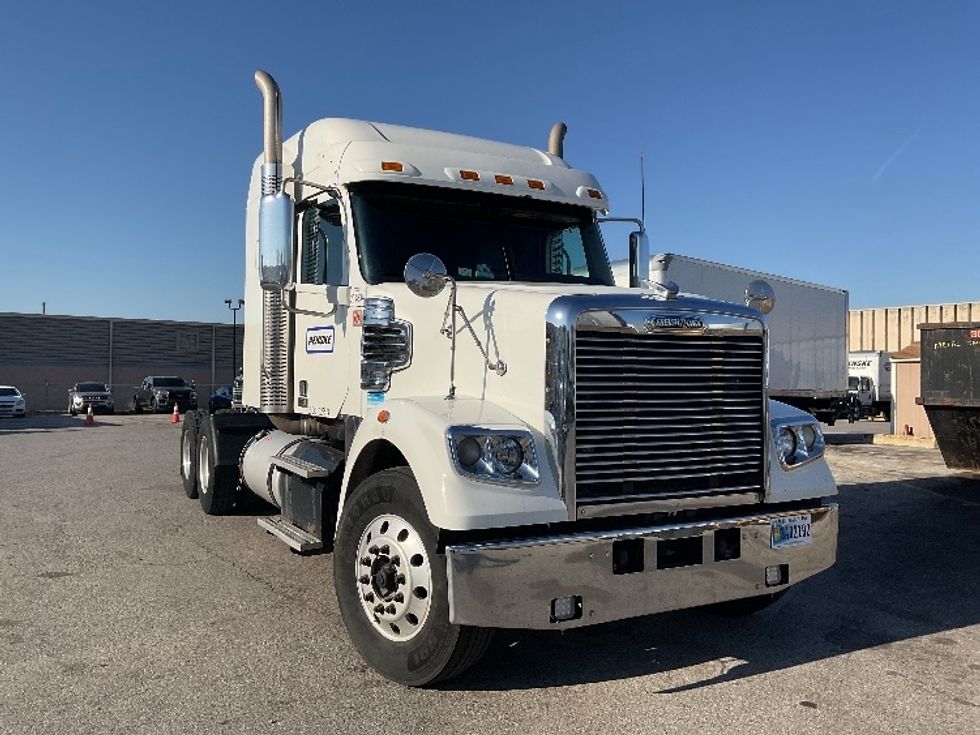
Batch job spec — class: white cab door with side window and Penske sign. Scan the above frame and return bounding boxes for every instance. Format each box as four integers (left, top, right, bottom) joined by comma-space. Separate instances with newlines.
293, 198, 351, 418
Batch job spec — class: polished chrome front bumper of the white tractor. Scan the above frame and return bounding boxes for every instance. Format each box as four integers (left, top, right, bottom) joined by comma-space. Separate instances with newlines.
446, 505, 837, 629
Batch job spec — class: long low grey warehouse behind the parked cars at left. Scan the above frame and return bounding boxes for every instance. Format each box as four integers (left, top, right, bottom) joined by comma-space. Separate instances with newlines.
0, 313, 244, 411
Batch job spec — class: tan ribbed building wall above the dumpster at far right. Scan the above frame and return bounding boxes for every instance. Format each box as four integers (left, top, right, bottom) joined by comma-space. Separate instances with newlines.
848, 301, 980, 352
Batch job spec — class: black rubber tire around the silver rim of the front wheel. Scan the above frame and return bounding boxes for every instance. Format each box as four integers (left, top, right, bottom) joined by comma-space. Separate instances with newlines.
334, 467, 493, 686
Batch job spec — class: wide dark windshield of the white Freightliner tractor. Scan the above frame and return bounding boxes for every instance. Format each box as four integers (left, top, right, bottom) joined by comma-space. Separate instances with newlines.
352, 182, 613, 286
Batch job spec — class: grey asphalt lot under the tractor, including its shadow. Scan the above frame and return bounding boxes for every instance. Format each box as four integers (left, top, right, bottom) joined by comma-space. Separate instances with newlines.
0, 416, 980, 735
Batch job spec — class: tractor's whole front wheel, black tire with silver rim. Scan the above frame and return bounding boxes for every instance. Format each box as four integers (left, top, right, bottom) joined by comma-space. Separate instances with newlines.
334, 467, 493, 686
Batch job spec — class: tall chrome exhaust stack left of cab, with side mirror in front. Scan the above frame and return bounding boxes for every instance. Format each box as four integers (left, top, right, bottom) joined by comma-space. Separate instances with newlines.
255, 69, 295, 413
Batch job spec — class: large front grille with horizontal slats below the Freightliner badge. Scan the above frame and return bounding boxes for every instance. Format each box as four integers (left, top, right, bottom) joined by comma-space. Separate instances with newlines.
575, 330, 765, 504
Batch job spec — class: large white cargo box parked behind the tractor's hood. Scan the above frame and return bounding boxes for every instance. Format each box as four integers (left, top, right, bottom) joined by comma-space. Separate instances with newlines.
613, 253, 848, 425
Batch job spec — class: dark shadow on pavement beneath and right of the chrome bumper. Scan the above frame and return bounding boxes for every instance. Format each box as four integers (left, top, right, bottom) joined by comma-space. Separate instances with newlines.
442, 476, 980, 694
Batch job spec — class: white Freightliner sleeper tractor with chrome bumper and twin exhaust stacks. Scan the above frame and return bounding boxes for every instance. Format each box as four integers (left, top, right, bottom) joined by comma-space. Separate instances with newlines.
180, 71, 837, 686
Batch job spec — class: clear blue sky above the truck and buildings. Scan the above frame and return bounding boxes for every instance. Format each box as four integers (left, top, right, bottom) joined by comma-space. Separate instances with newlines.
0, 0, 980, 321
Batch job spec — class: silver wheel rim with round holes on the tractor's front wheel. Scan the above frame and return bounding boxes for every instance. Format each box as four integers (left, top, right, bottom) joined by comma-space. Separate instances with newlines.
354, 514, 432, 643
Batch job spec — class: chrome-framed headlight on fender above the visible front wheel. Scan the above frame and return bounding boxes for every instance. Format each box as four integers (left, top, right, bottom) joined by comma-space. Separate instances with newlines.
448, 426, 539, 484
